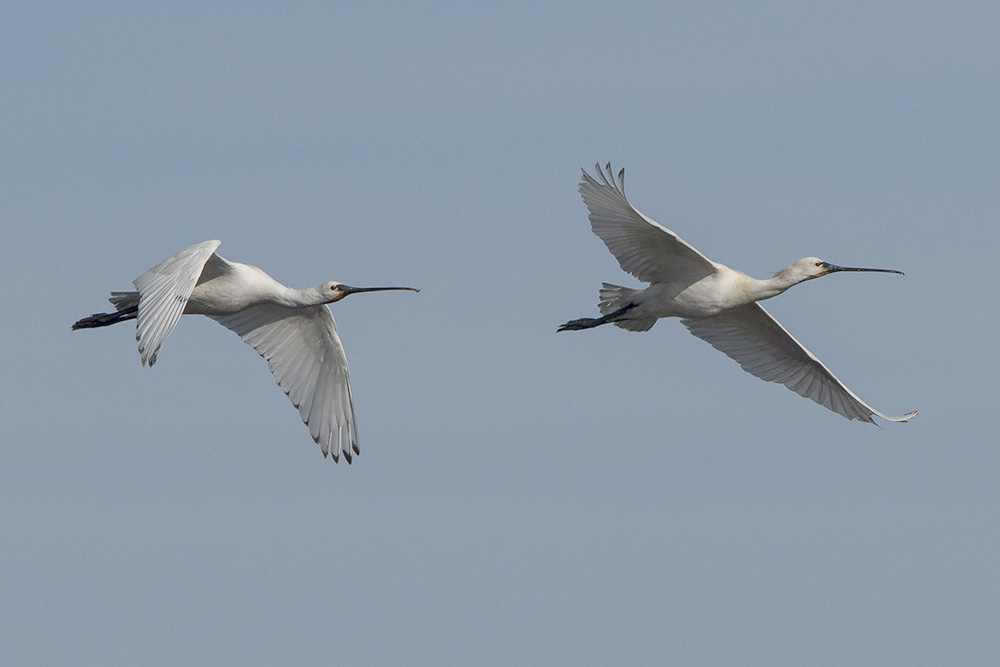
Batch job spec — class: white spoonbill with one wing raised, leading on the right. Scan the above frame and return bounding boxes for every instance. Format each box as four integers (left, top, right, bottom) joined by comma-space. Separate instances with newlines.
558, 163, 917, 424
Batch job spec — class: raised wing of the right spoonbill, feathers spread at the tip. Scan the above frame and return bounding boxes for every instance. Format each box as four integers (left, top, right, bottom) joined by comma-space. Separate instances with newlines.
580, 163, 716, 284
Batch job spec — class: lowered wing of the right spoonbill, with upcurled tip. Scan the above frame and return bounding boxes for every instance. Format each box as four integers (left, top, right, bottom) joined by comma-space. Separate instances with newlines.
681, 303, 917, 424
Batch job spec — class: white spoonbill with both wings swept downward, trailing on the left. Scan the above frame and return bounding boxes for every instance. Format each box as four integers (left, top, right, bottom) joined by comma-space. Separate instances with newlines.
73, 241, 420, 463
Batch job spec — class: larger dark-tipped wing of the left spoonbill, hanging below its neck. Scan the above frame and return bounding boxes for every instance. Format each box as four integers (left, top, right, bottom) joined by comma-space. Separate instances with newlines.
212, 304, 360, 463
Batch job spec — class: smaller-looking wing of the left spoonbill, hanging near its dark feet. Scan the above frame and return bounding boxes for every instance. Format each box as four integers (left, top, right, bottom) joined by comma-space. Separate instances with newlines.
132, 240, 222, 366
